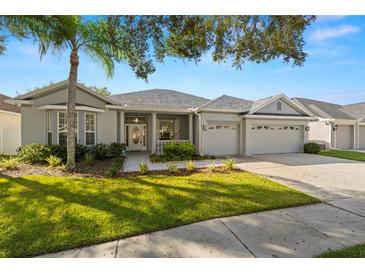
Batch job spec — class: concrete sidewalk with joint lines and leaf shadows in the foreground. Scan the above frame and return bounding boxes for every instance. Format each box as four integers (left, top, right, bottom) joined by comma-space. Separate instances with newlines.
42, 198, 365, 258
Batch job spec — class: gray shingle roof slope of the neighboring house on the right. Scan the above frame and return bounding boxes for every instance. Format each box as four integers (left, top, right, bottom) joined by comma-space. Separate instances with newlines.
295, 98, 356, 119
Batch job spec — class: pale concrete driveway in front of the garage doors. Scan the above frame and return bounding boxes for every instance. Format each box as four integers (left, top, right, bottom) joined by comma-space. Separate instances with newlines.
238, 153, 365, 201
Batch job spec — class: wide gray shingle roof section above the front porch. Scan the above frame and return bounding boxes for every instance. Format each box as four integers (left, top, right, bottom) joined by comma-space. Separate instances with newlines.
110, 89, 209, 109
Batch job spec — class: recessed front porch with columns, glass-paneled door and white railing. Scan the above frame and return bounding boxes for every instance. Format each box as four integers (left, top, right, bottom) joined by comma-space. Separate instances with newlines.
120, 112, 194, 154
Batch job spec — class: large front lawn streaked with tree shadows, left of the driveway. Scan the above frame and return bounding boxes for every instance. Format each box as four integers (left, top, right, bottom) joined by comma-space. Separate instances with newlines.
0, 172, 319, 257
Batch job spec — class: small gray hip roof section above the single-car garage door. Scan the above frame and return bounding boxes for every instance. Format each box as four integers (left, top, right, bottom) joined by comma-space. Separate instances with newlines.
199, 95, 253, 112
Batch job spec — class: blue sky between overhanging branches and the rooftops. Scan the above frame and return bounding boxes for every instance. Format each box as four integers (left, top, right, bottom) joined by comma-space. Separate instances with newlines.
0, 16, 365, 104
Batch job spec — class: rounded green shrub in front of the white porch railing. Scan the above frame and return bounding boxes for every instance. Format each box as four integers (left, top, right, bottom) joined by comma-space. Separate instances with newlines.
163, 143, 196, 161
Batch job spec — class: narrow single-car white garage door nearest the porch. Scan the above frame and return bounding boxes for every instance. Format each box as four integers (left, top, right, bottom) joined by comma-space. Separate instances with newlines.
207, 124, 239, 155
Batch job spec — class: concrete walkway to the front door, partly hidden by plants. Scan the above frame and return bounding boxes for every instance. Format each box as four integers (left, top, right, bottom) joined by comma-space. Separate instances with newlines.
123, 151, 222, 172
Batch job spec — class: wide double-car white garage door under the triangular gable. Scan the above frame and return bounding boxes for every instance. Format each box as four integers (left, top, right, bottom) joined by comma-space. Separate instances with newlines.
250, 125, 304, 154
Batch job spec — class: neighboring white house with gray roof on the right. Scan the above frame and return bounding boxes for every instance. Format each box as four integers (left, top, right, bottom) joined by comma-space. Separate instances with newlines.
293, 98, 365, 150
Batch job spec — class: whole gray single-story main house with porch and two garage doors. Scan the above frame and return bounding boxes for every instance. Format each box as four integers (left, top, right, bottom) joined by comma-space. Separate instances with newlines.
8, 81, 316, 155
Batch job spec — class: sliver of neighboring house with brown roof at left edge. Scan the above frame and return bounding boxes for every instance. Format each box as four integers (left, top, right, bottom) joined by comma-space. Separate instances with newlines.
0, 94, 21, 155
